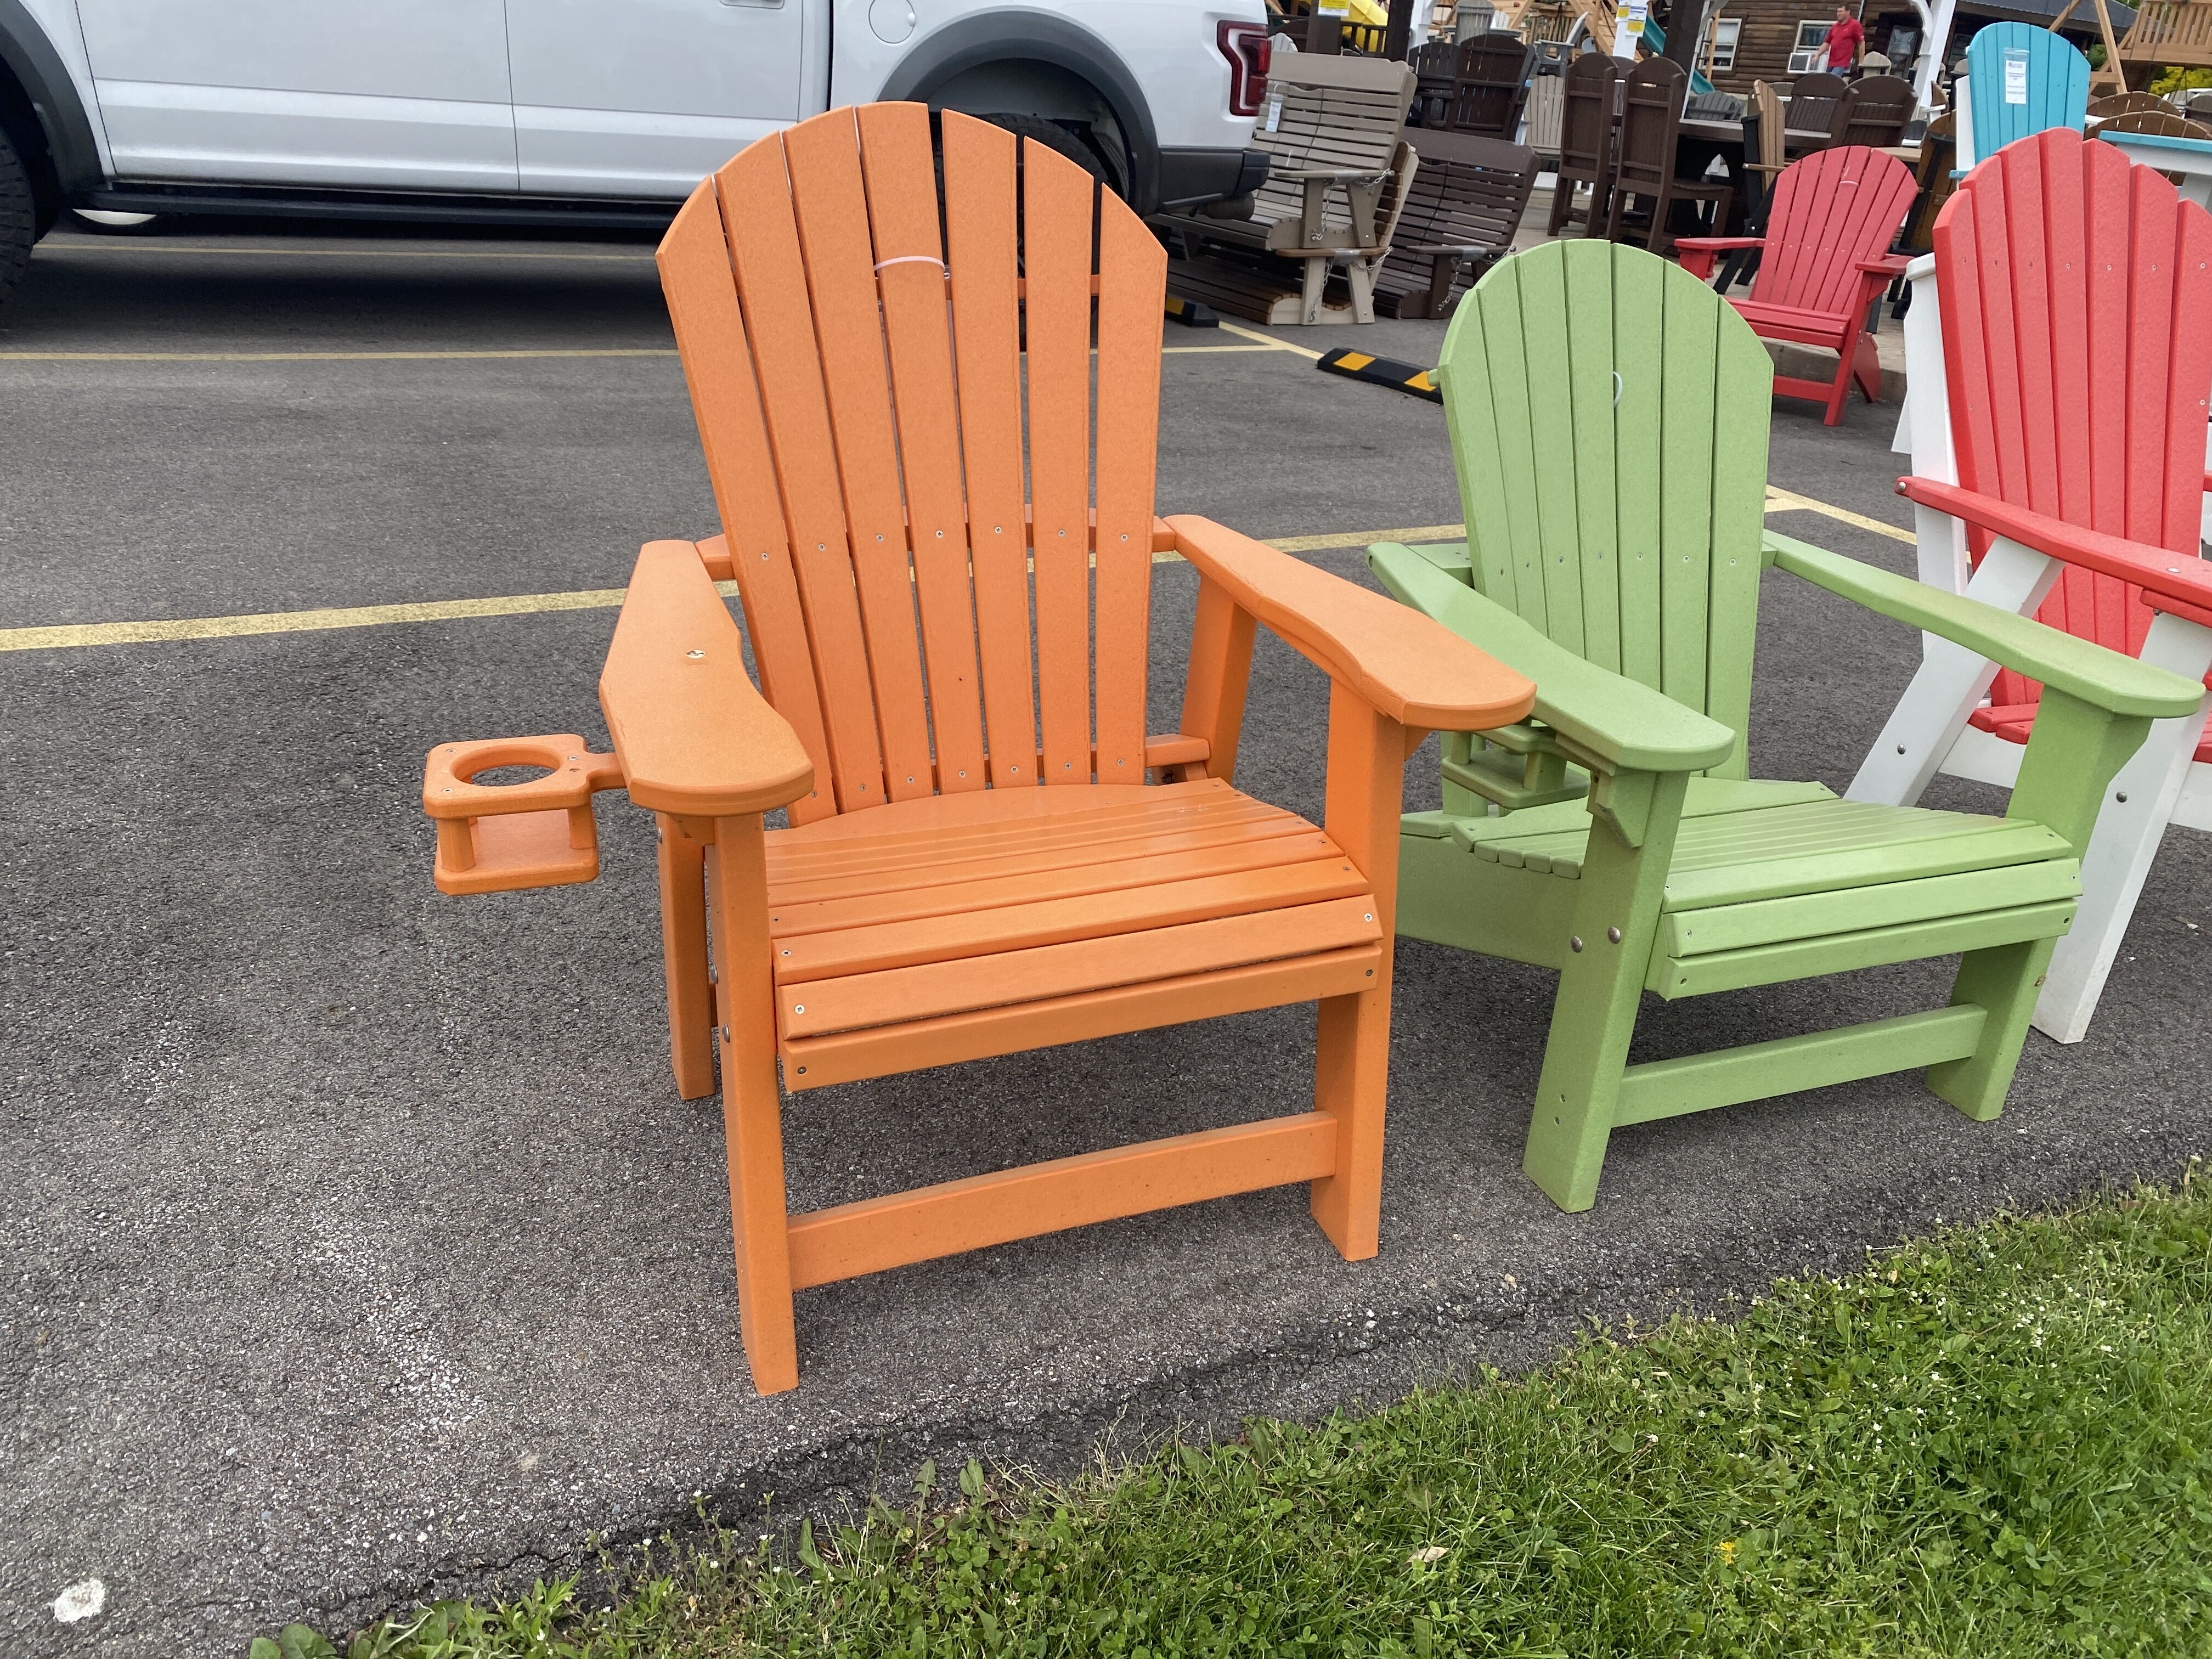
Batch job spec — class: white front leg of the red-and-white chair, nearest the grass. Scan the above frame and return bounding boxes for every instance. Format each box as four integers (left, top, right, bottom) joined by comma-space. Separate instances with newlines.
2035, 615, 2212, 1042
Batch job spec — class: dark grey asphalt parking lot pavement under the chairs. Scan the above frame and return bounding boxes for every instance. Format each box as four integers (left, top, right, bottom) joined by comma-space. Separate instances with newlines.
0, 225, 2212, 1659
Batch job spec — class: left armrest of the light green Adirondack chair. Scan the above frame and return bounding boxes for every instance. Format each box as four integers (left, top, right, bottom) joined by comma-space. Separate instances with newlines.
1367, 542, 1736, 772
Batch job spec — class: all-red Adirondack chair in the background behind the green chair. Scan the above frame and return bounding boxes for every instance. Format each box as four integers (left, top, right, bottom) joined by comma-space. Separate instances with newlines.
1674, 144, 1914, 427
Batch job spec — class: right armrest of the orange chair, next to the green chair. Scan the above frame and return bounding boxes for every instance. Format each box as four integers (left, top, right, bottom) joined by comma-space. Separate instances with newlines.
1159, 515, 1535, 734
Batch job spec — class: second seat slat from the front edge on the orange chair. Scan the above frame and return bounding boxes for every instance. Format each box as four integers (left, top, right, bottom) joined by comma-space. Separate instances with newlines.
776, 849, 1369, 984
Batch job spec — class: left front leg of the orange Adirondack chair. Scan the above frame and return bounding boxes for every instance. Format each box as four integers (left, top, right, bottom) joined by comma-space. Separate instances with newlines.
703, 814, 799, 1393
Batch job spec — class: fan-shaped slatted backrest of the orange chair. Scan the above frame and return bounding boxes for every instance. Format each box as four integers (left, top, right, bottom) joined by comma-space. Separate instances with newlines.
659, 104, 1168, 823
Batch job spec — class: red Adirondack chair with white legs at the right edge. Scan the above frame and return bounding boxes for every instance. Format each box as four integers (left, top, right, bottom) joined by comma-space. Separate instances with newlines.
1849, 126, 2212, 1042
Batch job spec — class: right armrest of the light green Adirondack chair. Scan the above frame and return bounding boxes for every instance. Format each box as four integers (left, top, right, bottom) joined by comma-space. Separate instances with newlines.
1760, 531, 2203, 719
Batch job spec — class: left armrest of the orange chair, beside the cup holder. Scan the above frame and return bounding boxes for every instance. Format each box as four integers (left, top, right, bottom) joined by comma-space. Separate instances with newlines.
600, 542, 814, 819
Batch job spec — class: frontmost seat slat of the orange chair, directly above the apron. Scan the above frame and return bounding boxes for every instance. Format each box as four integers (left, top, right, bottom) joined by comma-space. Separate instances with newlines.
776, 898, 1383, 1037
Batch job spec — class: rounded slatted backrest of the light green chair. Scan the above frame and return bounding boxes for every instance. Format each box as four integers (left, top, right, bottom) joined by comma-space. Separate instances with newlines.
1438, 241, 1774, 776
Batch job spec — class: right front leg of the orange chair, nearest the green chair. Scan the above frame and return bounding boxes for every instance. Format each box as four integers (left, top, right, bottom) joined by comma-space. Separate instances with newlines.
1312, 686, 1407, 1261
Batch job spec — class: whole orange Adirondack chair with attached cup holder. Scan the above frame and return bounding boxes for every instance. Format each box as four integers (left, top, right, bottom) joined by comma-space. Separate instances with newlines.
425, 104, 1533, 1393
